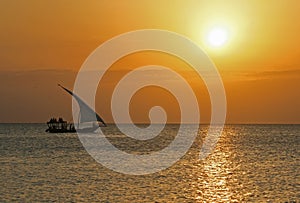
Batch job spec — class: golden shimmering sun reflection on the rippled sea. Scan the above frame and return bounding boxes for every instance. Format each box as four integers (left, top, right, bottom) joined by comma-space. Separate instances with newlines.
193, 127, 244, 202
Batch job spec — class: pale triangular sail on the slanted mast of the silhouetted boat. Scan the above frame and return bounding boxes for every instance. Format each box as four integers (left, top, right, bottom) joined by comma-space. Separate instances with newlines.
58, 84, 106, 126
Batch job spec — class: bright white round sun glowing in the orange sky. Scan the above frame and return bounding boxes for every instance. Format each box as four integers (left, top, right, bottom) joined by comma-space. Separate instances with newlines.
207, 27, 228, 47
